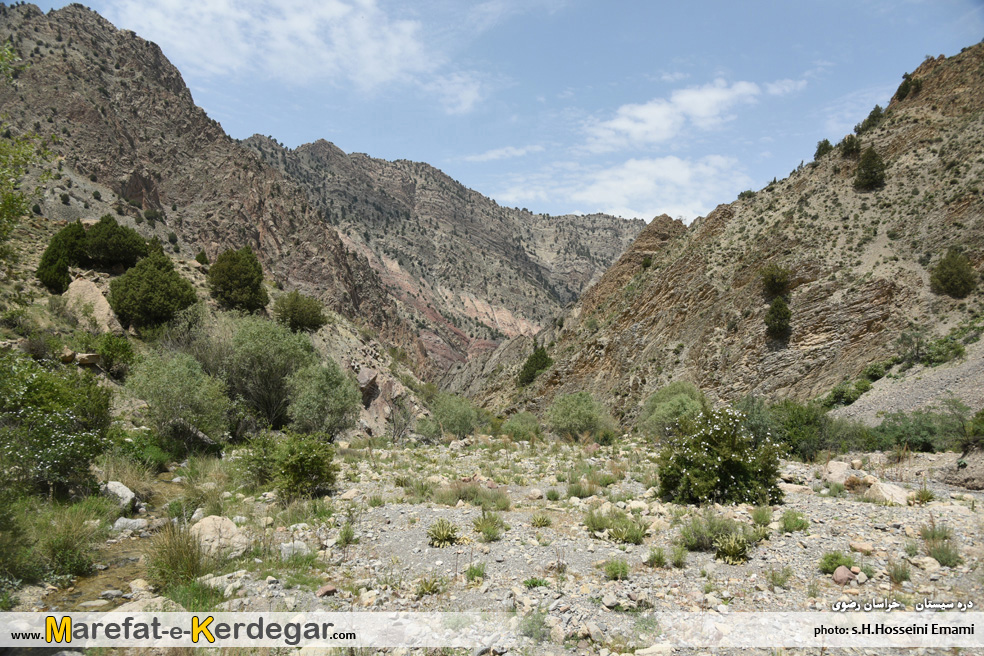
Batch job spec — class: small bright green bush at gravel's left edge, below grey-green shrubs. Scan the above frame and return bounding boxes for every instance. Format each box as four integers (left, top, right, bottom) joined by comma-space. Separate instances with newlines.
274, 431, 338, 501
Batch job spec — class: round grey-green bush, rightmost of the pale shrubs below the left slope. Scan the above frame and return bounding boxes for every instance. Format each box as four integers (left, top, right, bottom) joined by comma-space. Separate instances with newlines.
287, 358, 362, 437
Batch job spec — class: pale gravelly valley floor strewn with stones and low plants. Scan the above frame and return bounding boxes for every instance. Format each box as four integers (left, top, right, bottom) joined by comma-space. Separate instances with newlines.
9, 436, 984, 656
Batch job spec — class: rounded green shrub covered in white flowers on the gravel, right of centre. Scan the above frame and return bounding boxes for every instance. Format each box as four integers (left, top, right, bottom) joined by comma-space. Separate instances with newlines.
657, 408, 783, 504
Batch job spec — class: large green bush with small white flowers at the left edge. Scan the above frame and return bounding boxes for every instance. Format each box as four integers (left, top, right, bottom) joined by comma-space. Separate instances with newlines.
0, 352, 112, 495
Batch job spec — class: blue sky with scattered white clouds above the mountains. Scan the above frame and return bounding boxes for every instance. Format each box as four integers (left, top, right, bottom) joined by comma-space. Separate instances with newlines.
37, 0, 984, 223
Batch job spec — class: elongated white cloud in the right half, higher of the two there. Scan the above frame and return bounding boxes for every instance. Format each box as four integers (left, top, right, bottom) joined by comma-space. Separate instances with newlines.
587, 79, 761, 152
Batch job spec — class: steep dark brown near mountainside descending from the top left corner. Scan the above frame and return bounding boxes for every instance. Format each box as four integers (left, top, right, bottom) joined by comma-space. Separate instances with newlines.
0, 5, 423, 357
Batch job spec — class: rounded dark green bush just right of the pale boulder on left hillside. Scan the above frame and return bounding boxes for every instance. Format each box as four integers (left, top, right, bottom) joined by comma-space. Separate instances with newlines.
109, 251, 196, 328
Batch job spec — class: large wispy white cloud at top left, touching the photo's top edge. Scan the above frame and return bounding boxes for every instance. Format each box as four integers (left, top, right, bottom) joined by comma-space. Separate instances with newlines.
104, 0, 495, 114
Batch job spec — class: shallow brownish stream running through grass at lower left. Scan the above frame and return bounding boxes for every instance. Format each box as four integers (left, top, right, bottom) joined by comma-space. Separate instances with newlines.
43, 472, 183, 613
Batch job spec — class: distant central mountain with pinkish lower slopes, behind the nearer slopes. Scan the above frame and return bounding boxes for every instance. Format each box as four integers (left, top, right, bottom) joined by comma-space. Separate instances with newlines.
243, 135, 645, 364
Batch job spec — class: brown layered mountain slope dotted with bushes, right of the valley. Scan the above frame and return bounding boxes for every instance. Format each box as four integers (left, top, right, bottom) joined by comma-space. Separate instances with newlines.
448, 44, 984, 417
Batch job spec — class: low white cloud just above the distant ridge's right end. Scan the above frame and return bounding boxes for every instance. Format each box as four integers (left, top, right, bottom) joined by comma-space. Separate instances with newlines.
494, 155, 752, 222
